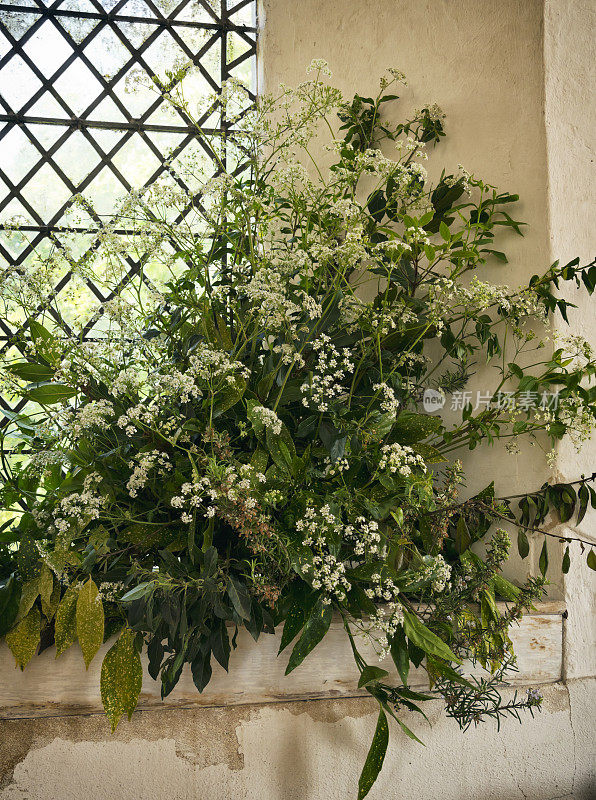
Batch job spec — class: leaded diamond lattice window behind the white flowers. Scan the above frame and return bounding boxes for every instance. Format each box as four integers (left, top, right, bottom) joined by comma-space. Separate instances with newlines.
0, 0, 256, 418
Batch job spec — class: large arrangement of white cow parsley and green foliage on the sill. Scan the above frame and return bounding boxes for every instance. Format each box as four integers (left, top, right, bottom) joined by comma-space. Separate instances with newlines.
0, 62, 596, 798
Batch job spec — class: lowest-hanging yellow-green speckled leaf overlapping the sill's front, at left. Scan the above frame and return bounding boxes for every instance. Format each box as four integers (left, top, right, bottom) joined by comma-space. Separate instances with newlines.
100, 628, 143, 733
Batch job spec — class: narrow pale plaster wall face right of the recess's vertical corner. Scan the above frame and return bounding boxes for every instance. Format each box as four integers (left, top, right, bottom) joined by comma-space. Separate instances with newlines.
544, 0, 596, 680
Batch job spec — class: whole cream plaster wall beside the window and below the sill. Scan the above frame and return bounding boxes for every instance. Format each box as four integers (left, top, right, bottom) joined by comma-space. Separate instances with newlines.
0, 0, 596, 800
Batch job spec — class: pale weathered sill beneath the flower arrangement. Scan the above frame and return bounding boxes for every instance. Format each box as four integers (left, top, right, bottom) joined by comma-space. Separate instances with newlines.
0, 602, 565, 719
